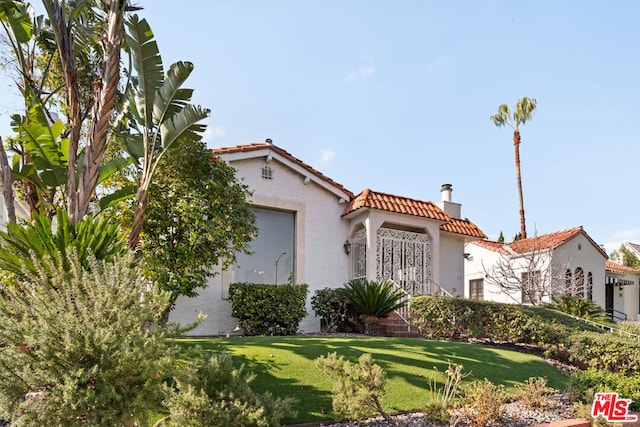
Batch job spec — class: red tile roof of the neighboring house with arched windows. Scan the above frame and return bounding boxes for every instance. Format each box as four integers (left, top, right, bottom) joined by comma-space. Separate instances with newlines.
473, 226, 609, 258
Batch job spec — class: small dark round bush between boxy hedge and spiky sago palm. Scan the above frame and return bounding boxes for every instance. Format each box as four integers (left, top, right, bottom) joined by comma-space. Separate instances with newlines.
311, 288, 353, 332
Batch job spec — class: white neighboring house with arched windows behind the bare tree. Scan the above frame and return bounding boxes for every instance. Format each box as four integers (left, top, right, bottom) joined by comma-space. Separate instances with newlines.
465, 227, 613, 307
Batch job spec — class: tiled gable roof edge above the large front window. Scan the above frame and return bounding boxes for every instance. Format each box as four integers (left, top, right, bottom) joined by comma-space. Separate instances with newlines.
211, 140, 354, 199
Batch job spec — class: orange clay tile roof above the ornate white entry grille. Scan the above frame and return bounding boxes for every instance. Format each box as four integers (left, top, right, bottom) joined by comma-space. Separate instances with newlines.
342, 188, 487, 239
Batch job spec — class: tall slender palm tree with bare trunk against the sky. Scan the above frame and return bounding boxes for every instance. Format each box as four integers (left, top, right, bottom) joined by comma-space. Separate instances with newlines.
490, 96, 536, 239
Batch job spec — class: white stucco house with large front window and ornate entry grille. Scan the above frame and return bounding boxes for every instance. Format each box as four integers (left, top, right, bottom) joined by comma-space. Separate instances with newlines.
171, 140, 486, 335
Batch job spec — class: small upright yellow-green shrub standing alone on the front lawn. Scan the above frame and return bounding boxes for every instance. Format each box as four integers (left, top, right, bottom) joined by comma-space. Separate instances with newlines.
316, 352, 393, 425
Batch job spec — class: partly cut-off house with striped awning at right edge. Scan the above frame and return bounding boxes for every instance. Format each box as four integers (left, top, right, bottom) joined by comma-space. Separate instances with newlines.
605, 260, 640, 321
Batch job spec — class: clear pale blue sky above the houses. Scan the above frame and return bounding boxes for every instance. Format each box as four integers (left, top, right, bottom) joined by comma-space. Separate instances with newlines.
0, 0, 640, 251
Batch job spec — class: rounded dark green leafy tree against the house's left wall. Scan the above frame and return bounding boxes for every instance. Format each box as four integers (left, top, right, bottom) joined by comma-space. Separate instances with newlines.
141, 141, 256, 312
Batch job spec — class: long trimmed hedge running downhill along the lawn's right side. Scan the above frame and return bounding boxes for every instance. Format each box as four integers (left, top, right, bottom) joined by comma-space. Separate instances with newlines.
411, 295, 640, 375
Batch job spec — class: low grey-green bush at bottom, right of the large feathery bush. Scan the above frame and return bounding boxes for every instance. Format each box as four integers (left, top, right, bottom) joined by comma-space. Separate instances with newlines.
164, 354, 295, 427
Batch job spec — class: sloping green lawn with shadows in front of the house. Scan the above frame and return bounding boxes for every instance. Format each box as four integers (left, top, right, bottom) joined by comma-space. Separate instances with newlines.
176, 337, 567, 424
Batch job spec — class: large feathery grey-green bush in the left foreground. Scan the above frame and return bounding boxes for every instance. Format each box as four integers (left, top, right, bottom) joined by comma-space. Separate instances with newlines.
0, 250, 173, 426
